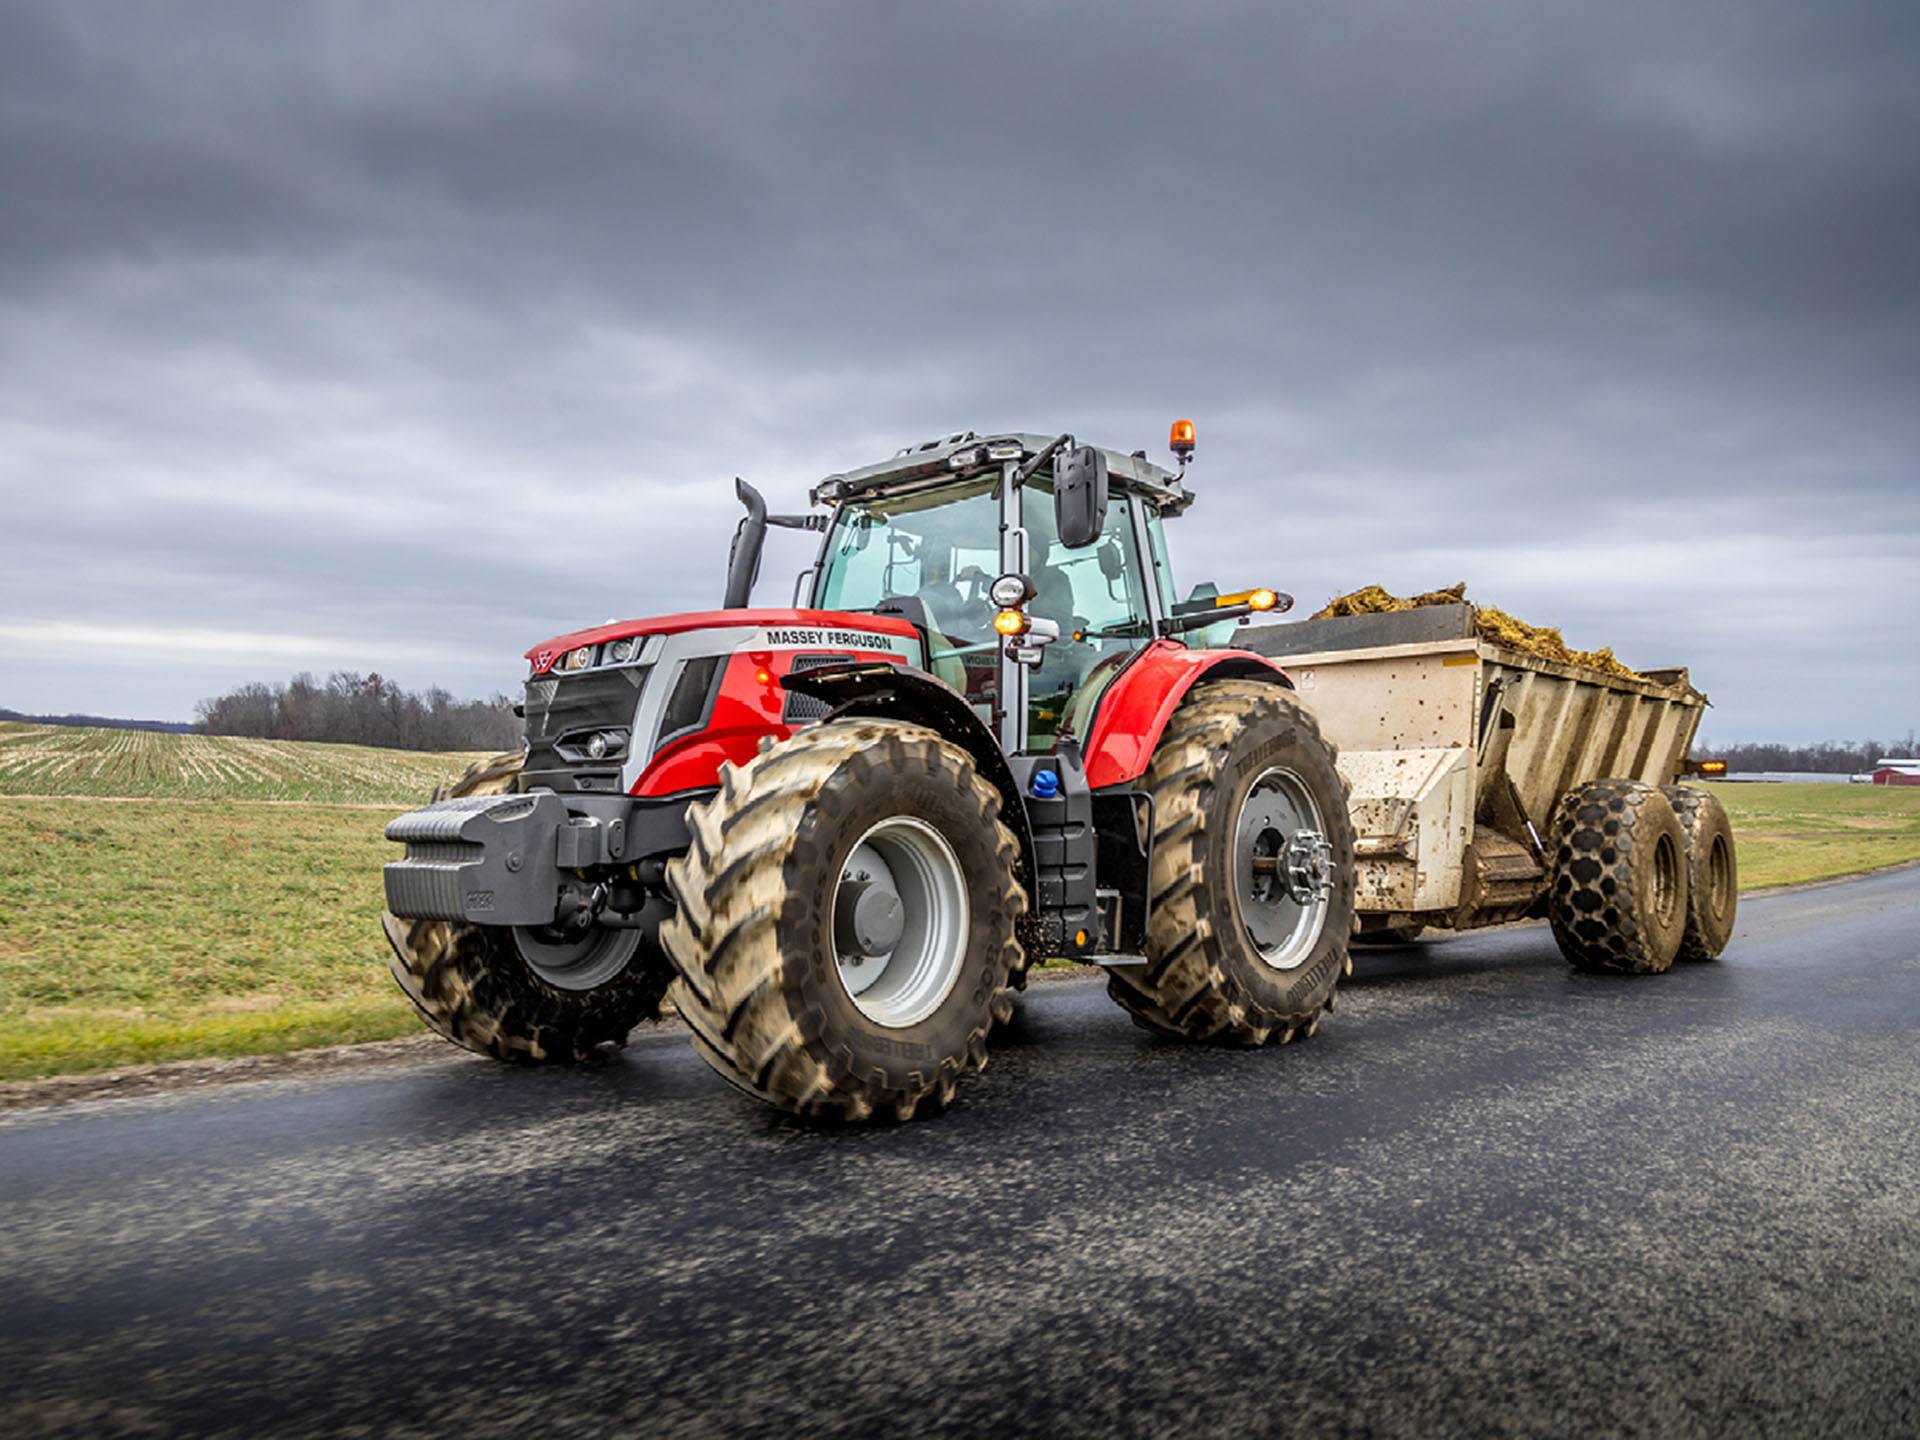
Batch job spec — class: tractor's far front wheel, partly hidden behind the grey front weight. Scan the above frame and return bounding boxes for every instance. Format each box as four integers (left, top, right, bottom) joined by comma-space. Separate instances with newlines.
380, 755, 674, 1064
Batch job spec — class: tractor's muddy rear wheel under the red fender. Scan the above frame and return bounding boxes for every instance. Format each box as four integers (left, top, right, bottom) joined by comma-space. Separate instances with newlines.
1106, 680, 1354, 1044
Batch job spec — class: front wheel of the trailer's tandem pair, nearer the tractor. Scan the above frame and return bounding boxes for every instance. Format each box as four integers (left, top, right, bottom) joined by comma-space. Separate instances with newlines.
1548, 780, 1688, 975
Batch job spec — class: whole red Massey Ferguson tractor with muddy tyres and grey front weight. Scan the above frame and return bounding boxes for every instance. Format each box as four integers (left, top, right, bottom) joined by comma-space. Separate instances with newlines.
386, 420, 1354, 1119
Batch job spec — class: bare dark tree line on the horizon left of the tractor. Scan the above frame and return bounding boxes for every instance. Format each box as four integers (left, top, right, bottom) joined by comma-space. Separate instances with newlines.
194, 670, 520, 751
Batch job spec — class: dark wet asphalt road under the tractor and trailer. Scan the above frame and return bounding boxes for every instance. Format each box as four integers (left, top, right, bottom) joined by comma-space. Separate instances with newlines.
0, 870, 1920, 1440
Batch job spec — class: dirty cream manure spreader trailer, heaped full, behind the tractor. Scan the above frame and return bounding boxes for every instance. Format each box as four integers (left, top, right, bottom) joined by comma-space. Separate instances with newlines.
1240, 591, 1736, 972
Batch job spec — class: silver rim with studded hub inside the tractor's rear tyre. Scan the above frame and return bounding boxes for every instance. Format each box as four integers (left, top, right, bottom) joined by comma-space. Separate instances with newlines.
1233, 766, 1332, 970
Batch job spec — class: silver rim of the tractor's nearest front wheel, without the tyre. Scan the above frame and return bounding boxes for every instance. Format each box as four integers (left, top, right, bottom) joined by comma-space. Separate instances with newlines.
833, 816, 968, 1029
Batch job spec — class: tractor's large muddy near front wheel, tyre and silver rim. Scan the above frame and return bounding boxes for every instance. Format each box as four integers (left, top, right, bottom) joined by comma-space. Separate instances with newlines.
660, 720, 1027, 1119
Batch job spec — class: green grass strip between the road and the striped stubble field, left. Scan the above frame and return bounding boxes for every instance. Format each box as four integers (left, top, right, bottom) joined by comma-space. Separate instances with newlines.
0, 799, 417, 1079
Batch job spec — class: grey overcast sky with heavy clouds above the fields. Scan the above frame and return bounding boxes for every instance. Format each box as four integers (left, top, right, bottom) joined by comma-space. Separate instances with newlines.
0, 0, 1920, 741
